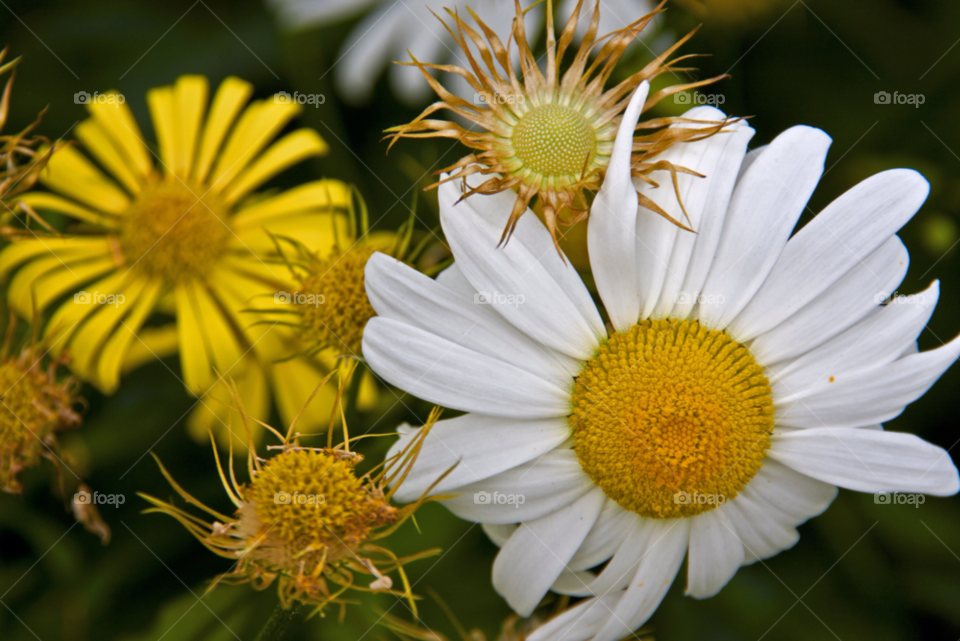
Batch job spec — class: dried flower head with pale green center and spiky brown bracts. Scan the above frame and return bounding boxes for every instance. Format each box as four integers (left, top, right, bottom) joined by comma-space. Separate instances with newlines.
387, 0, 725, 249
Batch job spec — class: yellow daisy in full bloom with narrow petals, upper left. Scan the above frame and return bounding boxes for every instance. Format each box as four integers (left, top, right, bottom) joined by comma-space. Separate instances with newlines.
0, 76, 349, 398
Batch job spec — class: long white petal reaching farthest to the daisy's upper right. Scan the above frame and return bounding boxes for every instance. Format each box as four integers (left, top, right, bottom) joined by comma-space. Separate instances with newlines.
727, 169, 930, 342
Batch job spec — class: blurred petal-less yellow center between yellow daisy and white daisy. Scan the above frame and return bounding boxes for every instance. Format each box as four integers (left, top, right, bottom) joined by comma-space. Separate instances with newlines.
297, 245, 376, 354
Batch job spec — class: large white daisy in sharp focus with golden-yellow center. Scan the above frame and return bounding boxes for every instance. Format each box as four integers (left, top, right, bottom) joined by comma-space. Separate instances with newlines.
363, 85, 960, 641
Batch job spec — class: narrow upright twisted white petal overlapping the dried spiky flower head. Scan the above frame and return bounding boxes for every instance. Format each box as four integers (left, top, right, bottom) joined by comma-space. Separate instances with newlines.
587, 81, 650, 331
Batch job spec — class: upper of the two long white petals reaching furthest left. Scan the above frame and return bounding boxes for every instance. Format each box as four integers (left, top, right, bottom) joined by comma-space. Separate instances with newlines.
364, 252, 580, 388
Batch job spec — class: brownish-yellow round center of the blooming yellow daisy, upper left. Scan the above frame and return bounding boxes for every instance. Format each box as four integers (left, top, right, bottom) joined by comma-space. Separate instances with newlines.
120, 182, 230, 282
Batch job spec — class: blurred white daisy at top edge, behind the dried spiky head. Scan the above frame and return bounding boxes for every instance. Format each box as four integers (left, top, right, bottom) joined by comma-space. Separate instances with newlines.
268, 0, 654, 105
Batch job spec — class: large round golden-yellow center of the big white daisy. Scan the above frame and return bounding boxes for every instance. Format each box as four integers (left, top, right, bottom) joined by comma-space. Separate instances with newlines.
570, 320, 774, 518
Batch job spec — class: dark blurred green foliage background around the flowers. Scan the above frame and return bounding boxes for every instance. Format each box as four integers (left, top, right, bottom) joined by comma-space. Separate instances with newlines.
0, 0, 960, 641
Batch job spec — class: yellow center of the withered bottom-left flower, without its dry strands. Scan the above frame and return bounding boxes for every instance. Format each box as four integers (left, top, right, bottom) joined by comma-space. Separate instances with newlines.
245, 449, 396, 572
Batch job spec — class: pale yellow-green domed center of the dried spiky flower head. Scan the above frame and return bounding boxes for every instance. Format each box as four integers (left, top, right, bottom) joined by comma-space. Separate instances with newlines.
513, 105, 597, 176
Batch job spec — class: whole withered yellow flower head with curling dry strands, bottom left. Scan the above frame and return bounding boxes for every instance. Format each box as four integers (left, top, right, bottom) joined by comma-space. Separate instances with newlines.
141, 384, 439, 612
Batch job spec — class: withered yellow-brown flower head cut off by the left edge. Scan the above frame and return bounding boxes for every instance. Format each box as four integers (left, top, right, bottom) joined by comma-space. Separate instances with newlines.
0, 336, 81, 493
